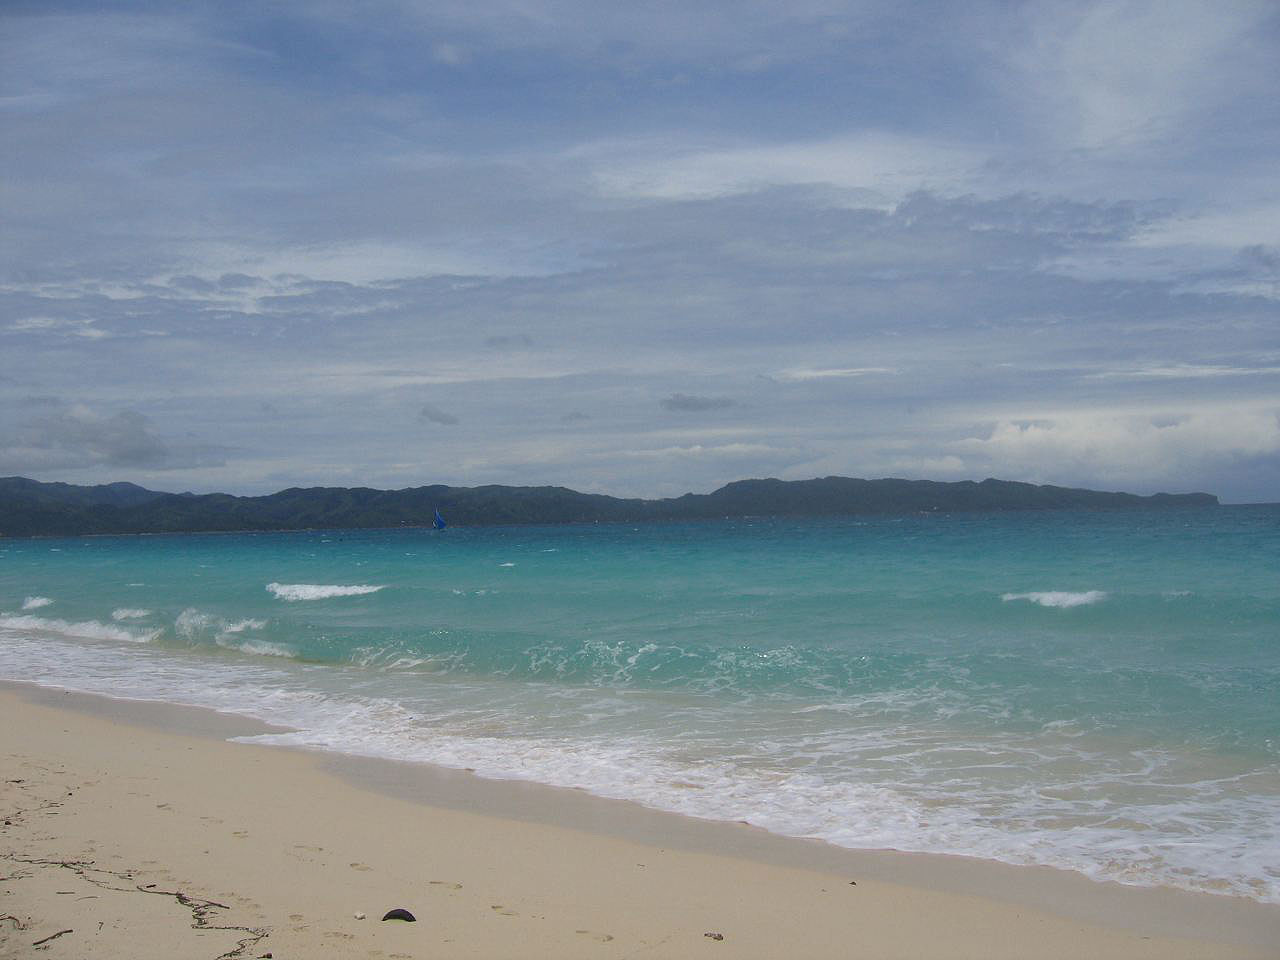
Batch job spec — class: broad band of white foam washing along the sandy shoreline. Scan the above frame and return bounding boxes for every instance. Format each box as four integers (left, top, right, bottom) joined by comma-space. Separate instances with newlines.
0, 636, 1280, 902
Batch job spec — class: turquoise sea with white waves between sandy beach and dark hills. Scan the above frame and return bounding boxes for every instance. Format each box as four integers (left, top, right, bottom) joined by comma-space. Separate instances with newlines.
0, 507, 1280, 902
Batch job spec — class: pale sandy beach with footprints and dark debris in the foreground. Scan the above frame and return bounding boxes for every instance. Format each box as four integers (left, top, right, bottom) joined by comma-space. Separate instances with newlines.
0, 685, 1280, 960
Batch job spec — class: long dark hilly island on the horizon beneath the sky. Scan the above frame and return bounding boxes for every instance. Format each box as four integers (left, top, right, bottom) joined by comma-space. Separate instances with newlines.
0, 476, 1217, 536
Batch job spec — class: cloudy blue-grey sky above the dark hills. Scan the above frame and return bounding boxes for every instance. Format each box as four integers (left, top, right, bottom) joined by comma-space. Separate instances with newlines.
0, 0, 1280, 502
